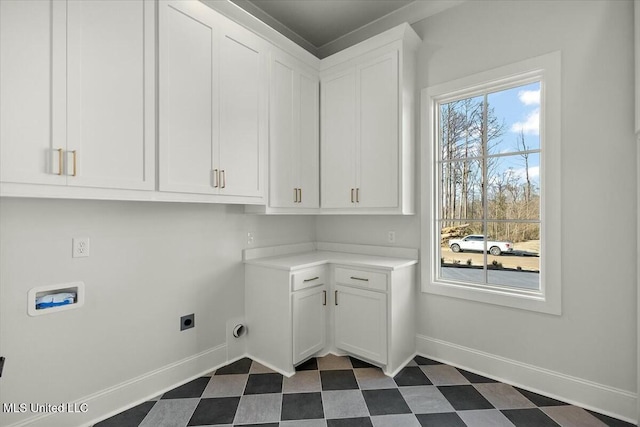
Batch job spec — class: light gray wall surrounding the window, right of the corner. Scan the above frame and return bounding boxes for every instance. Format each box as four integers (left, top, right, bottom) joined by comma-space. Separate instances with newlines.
316, 1, 637, 391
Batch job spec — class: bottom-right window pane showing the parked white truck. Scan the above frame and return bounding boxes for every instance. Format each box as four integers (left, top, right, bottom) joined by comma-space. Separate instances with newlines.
487, 223, 540, 290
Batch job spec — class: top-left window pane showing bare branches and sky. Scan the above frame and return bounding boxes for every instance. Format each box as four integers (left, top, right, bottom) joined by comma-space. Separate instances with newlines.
439, 96, 483, 160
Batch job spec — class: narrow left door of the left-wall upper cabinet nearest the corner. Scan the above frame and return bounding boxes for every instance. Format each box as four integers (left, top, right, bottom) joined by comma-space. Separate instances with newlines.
269, 57, 301, 208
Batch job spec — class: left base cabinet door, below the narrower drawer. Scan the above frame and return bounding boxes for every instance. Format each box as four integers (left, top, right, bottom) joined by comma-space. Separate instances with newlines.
292, 286, 327, 365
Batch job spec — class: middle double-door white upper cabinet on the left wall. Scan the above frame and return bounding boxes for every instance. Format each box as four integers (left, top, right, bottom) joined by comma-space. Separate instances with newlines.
159, 1, 267, 203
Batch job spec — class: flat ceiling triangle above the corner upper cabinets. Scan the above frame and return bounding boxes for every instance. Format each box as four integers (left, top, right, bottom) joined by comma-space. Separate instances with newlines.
232, 0, 414, 48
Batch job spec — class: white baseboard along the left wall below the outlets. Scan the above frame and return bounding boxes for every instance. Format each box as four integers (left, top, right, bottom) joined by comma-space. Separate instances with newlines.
8, 343, 229, 427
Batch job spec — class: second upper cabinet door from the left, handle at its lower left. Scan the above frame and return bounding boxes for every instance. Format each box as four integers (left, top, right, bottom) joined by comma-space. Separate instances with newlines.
66, 0, 155, 190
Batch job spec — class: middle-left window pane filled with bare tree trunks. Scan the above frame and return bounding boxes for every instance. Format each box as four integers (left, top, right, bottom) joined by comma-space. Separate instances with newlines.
439, 159, 483, 220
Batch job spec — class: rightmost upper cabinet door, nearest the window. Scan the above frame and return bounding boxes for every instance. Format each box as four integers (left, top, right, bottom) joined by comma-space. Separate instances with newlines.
356, 50, 399, 208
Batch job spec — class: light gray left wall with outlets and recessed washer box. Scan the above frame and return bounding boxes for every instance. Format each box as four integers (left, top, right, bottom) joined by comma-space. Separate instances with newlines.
0, 198, 315, 425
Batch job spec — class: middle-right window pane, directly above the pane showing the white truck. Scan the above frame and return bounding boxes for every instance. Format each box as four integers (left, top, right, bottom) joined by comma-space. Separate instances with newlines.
487, 153, 540, 220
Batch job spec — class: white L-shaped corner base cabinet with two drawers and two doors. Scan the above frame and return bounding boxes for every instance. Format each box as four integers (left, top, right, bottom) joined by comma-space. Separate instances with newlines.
245, 252, 416, 376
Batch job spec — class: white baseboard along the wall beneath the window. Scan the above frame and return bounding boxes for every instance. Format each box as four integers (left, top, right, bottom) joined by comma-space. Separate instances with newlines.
416, 335, 638, 424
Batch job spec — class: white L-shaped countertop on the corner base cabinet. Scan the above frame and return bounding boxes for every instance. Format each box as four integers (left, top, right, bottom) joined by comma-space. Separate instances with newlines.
245, 250, 418, 271
